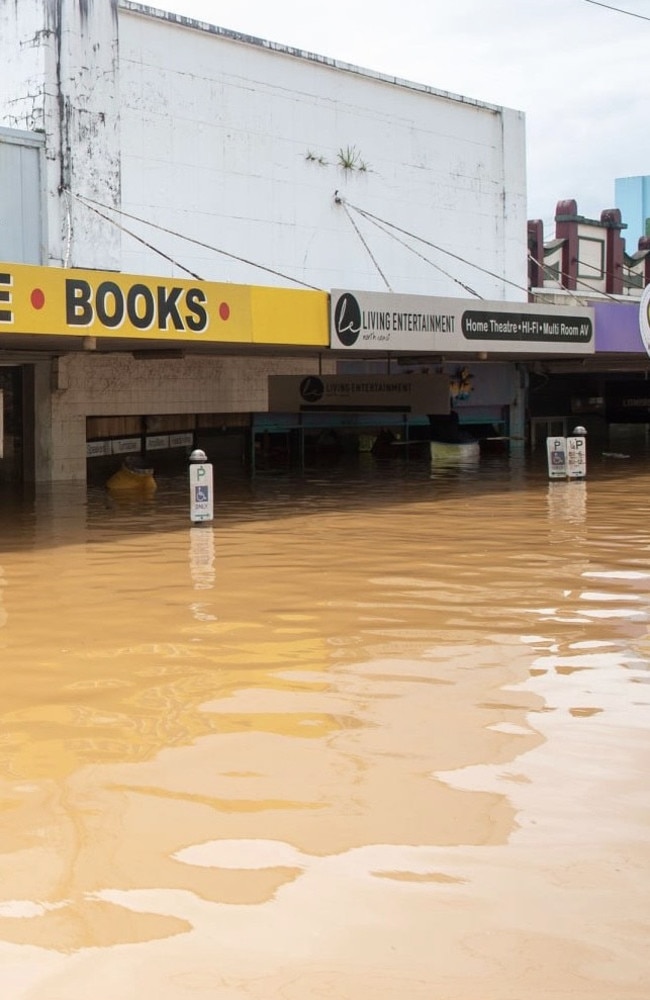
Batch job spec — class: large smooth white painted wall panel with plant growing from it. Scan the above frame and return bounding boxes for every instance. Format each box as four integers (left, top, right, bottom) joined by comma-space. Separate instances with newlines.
112, 7, 526, 299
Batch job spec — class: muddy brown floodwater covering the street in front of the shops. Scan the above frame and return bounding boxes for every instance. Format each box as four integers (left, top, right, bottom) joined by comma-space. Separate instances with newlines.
0, 456, 650, 1000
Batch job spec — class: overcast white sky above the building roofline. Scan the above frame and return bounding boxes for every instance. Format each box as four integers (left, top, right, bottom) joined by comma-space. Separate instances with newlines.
151, 0, 650, 236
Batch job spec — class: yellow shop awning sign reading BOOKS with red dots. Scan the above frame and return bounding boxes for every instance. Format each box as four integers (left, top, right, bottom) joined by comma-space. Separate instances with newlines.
0, 264, 328, 345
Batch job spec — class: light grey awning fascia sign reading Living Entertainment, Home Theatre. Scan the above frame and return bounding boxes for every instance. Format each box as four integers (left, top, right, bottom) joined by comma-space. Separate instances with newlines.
330, 290, 595, 355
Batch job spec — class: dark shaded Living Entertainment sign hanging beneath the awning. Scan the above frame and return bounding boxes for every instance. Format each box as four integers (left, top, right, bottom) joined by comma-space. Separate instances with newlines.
269, 375, 449, 414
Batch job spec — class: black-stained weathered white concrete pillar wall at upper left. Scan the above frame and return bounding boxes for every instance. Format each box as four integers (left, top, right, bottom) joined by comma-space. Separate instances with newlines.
0, 0, 121, 270
